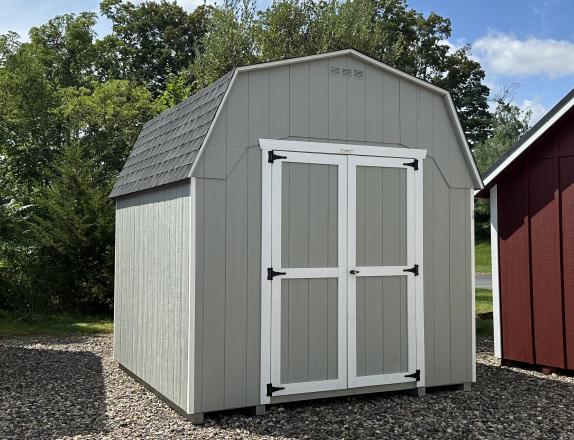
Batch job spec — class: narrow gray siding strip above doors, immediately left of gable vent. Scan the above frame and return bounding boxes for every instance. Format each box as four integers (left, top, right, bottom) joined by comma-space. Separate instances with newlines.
309, 60, 329, 139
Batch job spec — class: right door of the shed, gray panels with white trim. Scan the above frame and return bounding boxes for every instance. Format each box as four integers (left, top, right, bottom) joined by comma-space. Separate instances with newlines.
348, 157, 416, 387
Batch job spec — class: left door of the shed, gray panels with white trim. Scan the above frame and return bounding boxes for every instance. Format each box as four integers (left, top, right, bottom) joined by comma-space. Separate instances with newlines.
271, 151, 347, 396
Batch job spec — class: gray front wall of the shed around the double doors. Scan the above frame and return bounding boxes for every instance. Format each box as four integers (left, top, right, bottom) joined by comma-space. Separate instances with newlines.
194, 55, 473, 411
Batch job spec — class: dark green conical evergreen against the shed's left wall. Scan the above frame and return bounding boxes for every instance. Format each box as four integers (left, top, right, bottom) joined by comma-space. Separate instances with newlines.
28, 144, 114, 311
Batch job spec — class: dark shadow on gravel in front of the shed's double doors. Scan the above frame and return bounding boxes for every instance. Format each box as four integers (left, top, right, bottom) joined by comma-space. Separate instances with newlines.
206, 364, 574, 439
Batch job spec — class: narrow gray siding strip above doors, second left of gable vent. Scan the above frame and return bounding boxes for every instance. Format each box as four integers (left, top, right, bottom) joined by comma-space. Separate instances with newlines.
289, 63, 309, 137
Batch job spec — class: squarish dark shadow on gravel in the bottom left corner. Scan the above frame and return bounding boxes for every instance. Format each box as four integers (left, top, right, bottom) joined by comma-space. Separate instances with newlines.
0, 347, 106, 439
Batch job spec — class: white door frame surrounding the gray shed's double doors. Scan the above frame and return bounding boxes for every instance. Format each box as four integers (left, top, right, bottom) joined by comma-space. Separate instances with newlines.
259, 139, 427, 404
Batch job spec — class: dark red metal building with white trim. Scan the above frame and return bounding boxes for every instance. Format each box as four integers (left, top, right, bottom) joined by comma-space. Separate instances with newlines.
478, 90, 574, 370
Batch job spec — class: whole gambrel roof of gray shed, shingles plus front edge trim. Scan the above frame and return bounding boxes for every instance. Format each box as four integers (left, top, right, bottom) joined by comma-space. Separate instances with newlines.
110, 49, 482, 197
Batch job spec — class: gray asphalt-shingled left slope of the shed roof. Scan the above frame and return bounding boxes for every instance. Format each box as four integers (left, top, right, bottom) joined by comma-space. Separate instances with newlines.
110, 72, 233, 197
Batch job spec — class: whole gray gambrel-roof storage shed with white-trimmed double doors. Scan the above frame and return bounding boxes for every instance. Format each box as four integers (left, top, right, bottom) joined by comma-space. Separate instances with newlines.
111, 50, 482, 422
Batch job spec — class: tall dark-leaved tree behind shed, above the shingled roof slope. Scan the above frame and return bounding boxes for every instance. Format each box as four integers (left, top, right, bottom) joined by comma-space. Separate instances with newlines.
98, 0, 211, 96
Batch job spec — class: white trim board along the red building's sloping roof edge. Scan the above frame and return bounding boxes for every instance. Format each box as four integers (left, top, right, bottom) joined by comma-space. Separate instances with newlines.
484, 89, 574, 186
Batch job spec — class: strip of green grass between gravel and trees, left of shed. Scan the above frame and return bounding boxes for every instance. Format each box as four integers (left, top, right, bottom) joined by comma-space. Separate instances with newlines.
0, 311, 113, 337
